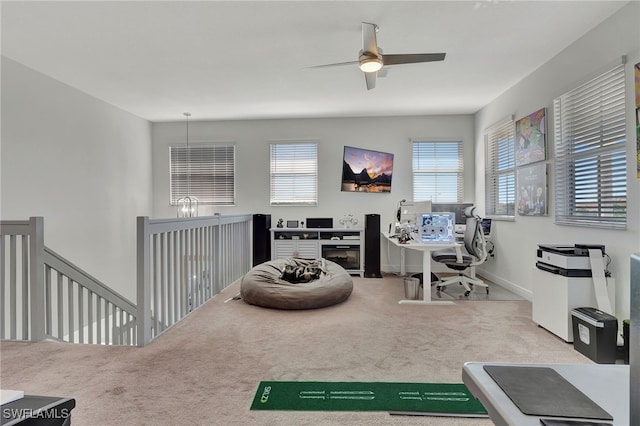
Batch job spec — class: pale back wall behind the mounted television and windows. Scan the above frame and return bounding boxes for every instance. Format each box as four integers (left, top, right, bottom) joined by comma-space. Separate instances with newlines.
153, 115, 475, 271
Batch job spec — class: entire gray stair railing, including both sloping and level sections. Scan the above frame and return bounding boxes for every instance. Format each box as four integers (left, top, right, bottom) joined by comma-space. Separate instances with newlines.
0, 215, 251, 346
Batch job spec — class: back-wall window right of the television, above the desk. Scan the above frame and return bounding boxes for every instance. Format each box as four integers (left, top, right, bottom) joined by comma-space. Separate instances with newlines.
413, 141, 464, 203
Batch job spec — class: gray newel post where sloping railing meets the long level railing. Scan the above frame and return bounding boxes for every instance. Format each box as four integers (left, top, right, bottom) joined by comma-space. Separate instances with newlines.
136, 216, 151, 346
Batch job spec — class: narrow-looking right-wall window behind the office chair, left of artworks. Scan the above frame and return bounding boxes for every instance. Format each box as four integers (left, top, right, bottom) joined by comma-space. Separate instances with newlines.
484, 118, 516, 218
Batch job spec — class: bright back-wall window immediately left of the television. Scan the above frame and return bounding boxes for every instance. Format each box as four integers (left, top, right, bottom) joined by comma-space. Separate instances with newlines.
271, 142, 318, 206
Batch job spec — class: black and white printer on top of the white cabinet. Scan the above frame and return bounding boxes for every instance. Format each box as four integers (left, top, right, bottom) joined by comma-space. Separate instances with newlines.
536, 244, 605, 277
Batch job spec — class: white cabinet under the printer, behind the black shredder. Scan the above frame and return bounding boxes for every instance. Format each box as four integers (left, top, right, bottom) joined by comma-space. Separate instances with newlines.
532, 268, 615, 342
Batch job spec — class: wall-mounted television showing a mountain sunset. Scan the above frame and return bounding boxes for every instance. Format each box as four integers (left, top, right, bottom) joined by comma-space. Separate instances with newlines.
342, 146, 393, 192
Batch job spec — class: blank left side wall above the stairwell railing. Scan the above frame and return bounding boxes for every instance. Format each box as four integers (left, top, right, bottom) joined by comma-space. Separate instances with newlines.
0, 57, 151, 302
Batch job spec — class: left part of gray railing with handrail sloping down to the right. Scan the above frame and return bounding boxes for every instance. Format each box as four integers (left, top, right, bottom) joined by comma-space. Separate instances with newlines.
0, 217, 137, 345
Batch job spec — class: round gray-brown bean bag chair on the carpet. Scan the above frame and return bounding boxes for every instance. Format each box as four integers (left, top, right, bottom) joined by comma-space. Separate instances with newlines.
240, 258, 353, 309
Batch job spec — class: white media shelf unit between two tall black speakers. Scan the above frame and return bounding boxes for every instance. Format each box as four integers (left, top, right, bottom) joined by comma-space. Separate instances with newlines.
271, 228, 364, 276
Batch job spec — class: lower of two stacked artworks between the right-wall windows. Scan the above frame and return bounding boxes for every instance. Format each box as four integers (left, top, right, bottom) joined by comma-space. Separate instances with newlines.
516, 163, 548, 216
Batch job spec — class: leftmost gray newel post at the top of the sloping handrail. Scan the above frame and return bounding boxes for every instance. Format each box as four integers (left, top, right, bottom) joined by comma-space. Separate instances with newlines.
29, 216, 45, 342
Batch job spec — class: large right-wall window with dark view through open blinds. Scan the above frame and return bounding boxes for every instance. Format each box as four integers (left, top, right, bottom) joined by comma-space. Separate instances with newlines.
553, 65, 627, 229
